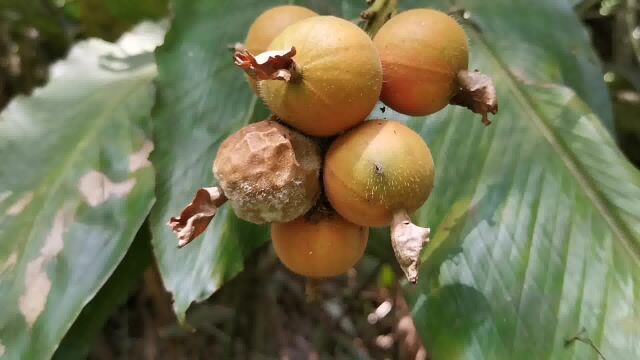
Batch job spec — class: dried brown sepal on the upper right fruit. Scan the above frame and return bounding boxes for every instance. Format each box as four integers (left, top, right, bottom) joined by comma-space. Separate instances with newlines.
450, 70, 498, 125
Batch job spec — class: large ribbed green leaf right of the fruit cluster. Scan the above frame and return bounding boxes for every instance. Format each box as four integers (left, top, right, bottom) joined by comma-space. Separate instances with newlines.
396, 0, 640, 360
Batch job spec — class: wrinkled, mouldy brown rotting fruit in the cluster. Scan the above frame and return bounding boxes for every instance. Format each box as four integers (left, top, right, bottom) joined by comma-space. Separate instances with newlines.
213, 120, 322, 224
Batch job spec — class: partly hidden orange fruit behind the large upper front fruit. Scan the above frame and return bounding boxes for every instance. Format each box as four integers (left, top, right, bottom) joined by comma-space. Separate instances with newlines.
244, 5, 318, 92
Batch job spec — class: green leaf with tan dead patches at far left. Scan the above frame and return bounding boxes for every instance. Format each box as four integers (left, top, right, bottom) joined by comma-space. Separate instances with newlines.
0, 25, 162, 360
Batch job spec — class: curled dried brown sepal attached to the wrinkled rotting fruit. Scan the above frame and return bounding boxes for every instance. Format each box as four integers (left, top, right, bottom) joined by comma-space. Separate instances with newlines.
168, 187, 227, 248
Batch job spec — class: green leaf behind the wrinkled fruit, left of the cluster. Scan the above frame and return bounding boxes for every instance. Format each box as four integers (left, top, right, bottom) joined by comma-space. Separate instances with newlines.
150, 0, 278, 319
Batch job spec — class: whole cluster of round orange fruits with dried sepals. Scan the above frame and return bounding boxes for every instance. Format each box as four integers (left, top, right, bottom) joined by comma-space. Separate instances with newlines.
170, 2, 496, 282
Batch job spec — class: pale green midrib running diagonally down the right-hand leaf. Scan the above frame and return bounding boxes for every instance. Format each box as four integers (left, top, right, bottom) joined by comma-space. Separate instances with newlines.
467, 29, 640, 267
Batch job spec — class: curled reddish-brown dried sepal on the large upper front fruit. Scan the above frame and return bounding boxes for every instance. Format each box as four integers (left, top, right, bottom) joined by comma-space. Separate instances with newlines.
233, 46, 299, 81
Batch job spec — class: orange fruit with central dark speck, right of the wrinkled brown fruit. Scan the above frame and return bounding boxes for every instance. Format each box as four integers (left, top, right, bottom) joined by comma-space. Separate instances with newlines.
324, 120, 434, 227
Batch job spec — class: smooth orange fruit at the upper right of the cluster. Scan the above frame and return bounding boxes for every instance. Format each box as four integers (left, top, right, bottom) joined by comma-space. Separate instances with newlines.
373, 9, 469, 116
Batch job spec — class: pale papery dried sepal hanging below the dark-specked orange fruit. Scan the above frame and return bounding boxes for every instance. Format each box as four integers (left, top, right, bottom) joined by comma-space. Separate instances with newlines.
391, 210, 431, 284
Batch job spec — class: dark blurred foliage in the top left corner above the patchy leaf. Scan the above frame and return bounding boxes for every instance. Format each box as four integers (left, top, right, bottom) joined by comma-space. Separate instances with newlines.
0, 0, 168, 109
